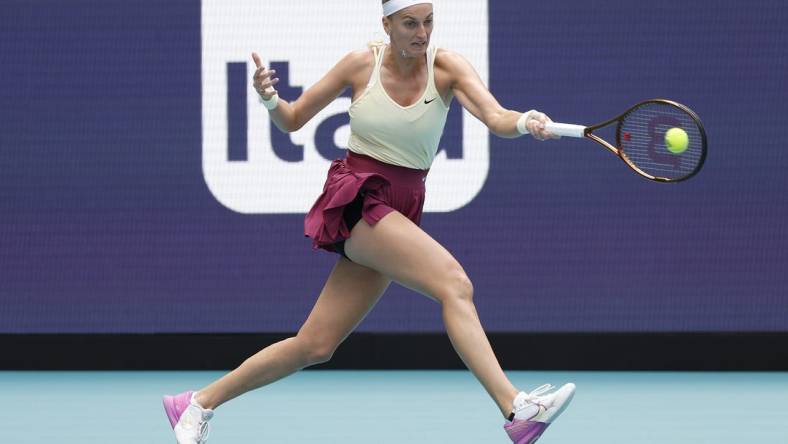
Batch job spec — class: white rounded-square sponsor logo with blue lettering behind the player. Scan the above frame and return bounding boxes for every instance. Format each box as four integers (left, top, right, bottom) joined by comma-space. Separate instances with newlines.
202, 0, 489, 214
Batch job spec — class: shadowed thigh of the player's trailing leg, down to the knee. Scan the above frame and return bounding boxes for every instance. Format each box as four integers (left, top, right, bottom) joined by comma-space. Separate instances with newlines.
298, 258, 391, 349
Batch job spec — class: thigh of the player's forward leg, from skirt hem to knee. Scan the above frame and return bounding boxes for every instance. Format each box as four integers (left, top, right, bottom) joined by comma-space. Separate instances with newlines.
345, 211, 472, 302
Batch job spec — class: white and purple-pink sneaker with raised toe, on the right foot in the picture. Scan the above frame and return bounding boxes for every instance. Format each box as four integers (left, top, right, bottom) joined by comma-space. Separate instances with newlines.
503, 382, 575, 444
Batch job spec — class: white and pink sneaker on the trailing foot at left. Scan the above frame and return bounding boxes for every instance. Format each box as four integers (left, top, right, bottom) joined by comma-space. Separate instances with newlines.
162, 392, 213, 444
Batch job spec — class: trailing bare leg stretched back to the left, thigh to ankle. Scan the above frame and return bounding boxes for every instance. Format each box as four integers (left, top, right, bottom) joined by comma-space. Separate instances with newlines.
196, 258, 391, 409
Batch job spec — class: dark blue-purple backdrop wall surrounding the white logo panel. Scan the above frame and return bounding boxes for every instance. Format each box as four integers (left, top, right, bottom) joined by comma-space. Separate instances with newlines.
0, 0, 788, 332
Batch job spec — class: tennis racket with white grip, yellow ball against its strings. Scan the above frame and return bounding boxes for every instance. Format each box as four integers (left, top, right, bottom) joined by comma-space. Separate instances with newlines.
545, 99, 706, 182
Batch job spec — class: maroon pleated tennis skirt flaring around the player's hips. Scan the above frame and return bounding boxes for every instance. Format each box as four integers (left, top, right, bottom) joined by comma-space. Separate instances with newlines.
304, 150, 429, 251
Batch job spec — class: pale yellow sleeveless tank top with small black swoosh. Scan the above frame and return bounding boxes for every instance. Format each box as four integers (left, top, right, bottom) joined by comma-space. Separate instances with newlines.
348, 45, 449, 170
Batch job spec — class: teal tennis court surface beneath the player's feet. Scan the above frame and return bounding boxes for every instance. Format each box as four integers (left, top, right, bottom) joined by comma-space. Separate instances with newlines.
0, 371, 788, 444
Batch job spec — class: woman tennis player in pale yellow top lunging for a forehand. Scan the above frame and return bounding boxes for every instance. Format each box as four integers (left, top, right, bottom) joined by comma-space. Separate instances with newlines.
164, 0, 575, 444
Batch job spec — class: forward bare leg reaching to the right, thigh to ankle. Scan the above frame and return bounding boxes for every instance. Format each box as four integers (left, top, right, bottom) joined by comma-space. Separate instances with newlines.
345, 211, 517, 417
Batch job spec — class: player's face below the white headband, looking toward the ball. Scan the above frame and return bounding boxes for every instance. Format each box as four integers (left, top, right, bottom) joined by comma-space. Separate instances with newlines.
383, 3, 432, 57
